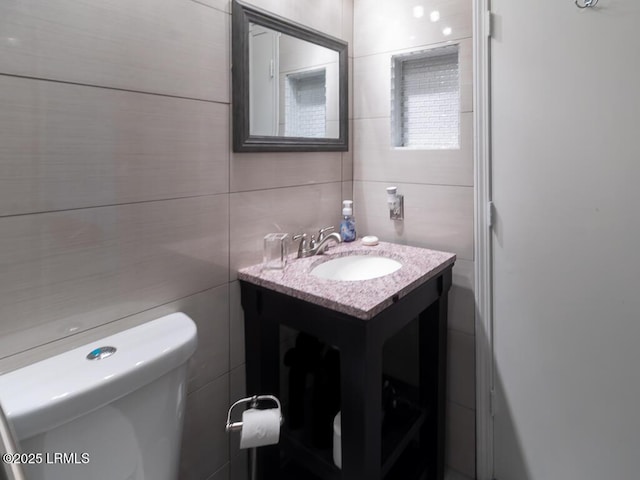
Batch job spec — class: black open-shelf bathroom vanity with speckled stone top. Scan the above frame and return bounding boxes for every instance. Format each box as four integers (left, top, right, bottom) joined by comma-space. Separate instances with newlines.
238, 241, 455, 480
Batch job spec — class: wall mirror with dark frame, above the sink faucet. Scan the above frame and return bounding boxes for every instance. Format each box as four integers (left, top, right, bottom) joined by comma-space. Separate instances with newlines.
231, 0, 349, 152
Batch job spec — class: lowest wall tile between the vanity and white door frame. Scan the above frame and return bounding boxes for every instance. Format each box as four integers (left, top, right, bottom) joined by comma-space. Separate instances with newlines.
446, 402, 476, 478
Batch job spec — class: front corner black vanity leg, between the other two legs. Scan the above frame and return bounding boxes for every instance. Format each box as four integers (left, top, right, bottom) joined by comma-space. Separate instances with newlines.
340, 339, 382, 480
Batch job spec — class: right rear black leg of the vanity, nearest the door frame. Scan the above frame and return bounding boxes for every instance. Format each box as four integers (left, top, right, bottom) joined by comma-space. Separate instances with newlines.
419, 291, 447, 480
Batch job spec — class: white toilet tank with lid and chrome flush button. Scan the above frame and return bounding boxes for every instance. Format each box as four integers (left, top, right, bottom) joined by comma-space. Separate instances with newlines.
0, 313, 197, 480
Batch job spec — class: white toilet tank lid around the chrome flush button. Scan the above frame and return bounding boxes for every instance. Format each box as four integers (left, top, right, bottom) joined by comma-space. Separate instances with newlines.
0, 312, 197, 440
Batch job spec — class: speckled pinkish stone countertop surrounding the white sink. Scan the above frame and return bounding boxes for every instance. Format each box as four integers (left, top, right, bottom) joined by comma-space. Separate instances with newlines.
238, 240, 456, 320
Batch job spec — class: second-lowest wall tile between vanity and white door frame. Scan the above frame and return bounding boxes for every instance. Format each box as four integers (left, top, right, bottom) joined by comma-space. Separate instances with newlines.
447, 330, 476, 410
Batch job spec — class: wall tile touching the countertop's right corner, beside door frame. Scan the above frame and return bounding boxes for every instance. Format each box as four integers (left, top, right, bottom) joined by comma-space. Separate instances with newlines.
448, 258, 475, 335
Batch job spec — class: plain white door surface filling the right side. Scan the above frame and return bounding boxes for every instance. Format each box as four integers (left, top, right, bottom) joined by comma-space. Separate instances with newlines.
492, 0, 640, 480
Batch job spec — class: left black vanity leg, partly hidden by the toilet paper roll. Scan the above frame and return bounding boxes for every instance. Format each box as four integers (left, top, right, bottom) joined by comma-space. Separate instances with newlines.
240, 286, 280, 480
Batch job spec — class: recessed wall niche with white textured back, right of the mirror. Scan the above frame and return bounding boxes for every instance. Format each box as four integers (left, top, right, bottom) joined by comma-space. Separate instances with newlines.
391, 45, 460, 149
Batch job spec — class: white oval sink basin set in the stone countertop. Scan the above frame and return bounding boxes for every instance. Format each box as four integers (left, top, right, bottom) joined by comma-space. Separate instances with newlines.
311, 255, 402, 281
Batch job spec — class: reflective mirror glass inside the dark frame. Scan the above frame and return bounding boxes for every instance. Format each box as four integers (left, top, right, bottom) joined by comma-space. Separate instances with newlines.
249, 23, 340, 138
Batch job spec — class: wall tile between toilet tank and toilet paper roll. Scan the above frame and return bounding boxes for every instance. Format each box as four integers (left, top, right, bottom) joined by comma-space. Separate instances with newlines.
180, 375, 229, 480
